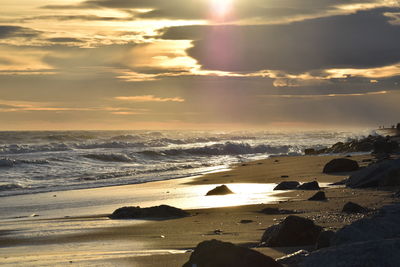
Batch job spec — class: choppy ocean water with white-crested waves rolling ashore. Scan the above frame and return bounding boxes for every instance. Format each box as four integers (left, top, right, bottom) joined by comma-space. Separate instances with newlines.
0, 131, 369, 196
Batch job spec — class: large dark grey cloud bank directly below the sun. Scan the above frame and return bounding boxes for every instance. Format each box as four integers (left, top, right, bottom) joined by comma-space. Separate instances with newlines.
162, 9, 400, 73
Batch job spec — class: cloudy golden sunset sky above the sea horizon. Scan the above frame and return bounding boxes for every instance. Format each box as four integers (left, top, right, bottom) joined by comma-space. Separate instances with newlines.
0, 0, 400, 130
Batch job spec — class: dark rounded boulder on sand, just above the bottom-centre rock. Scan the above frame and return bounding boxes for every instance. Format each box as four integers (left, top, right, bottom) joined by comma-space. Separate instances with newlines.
261, 215, 322, 247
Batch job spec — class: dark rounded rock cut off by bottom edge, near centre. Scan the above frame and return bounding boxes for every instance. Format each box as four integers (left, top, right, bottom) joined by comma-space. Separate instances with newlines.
183, 240, 282, 267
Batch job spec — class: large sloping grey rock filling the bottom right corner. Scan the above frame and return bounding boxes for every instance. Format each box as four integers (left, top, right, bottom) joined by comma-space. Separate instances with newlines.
298, 238, 400, 267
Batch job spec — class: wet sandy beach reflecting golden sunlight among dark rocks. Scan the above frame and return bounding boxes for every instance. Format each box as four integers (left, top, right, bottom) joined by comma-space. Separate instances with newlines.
0, 155, 395, 266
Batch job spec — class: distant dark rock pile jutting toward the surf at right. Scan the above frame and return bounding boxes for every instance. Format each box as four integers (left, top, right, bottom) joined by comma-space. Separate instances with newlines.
304, 135, 400, 155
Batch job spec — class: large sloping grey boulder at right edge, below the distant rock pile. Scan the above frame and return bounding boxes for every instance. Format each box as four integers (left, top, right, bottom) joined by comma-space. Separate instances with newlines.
346, 159, 400, 188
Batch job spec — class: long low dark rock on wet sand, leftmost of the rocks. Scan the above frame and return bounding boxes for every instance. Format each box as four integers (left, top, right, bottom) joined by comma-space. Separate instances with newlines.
109, 205, 190, 219
